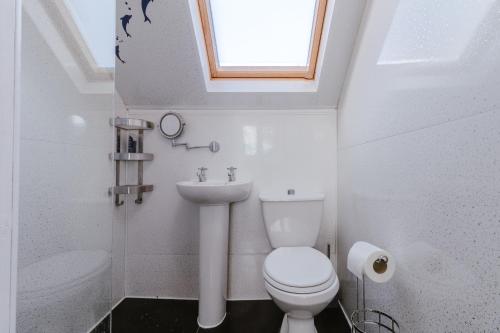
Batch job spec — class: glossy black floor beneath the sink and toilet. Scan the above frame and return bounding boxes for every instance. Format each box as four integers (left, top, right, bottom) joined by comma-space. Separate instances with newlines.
109, 298, 350, 333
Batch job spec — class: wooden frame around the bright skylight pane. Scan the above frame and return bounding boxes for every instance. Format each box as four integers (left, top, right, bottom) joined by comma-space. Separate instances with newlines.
197, 0, 328, 80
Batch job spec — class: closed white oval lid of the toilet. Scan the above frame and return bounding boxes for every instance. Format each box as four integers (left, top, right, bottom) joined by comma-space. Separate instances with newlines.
264, 247, 333, 288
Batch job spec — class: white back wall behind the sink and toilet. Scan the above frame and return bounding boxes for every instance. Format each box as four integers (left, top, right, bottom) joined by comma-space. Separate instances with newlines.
126, 110, 337, 299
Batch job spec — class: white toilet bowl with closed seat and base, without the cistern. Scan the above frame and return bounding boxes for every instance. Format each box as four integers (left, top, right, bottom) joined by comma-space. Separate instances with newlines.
263, 247, 339, 333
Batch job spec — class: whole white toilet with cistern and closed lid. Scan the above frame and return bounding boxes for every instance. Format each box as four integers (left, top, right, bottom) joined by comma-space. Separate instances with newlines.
260, 191, 339, 333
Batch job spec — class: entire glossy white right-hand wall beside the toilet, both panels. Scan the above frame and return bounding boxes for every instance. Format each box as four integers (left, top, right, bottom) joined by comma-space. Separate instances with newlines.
338, 0, 500, 333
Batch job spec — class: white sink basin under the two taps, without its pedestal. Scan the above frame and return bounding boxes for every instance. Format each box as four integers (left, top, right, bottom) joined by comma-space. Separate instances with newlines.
177, 180, 252, 205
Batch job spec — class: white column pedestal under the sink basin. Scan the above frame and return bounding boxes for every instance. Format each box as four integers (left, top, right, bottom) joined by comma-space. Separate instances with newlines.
198, 204, 229, 328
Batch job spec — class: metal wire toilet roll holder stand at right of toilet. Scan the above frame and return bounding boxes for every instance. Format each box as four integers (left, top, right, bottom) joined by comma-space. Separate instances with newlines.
351, 256, 400, 333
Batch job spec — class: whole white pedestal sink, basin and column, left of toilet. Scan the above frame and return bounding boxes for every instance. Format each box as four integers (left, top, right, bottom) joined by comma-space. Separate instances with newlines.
177, 180, 252, 328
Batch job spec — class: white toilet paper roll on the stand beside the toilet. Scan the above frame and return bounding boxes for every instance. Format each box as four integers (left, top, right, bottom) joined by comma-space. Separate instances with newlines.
347, 242, 396, 283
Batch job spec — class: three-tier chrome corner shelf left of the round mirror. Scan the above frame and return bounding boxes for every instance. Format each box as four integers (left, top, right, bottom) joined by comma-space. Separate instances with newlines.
109, 117, 155, 206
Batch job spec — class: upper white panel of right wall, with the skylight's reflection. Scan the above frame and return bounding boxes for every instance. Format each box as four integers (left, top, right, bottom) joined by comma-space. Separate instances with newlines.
339, 0, 500, 147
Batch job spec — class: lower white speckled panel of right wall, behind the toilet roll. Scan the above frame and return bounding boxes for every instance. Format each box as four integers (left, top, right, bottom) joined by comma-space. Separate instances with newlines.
339, 111, 500, 332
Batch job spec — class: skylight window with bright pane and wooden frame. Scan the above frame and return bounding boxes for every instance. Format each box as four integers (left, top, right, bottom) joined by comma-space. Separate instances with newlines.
198, 0, 327, 79
